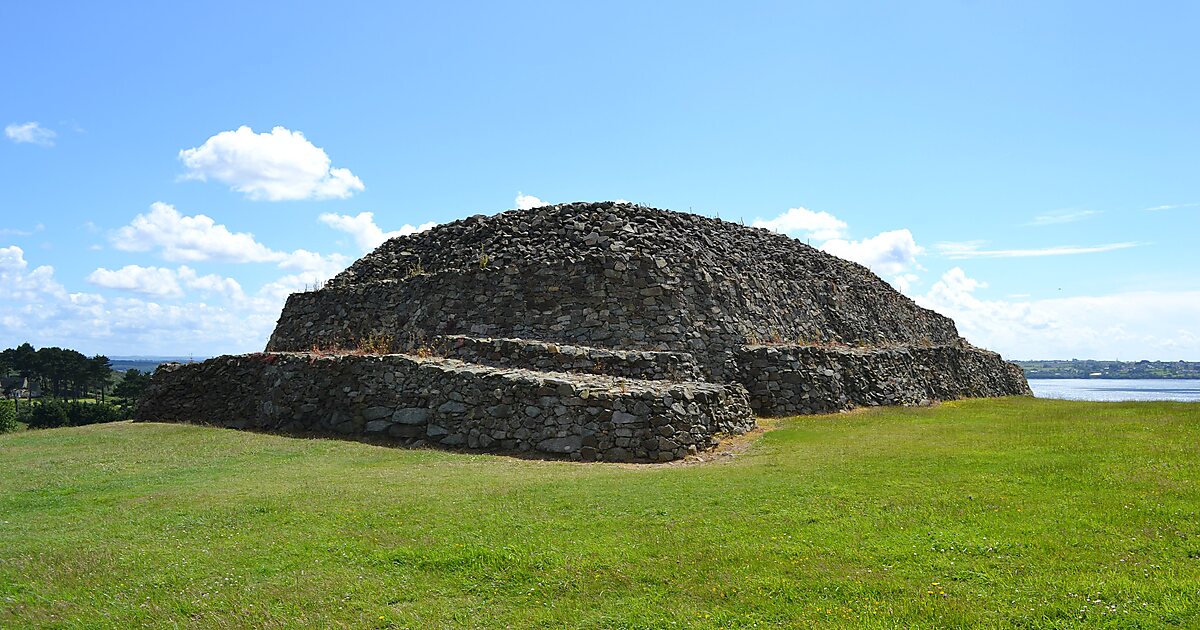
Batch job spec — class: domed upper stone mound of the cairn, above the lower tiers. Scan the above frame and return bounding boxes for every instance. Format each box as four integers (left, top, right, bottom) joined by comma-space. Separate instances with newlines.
268, 202, 964, 368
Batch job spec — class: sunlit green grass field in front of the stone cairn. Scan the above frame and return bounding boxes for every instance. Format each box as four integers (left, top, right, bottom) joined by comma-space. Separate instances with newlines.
0, 398, 1200, 628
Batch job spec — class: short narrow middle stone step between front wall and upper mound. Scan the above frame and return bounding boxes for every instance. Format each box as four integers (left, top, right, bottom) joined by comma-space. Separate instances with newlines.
431, 335, 701, 382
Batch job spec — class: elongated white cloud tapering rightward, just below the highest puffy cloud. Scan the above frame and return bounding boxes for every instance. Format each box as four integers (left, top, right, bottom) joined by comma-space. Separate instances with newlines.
110, 202, 347, 272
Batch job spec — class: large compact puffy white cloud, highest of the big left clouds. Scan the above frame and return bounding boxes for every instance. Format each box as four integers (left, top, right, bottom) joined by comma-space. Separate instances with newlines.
179, 126, 364, 202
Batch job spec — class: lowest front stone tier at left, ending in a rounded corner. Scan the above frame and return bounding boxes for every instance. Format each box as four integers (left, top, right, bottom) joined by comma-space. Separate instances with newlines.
136, 353, 754, 462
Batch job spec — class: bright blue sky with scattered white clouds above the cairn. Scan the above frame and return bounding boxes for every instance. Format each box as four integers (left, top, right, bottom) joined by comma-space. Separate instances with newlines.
0, 1, 1200, 360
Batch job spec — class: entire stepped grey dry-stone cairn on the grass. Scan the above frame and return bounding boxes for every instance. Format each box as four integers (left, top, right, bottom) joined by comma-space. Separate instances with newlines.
137, 203, 1030, 462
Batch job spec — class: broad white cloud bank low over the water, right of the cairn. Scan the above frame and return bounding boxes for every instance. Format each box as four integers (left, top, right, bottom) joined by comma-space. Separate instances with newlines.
916, 268, 1200, 360
